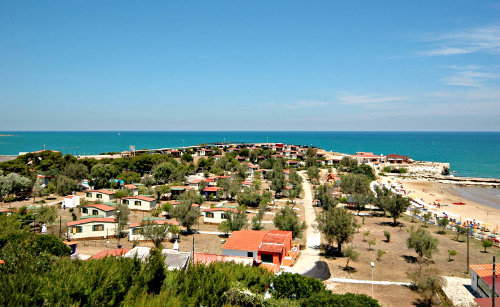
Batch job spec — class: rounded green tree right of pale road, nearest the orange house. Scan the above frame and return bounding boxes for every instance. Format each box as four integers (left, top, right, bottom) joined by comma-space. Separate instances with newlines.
316, 208, 356, 254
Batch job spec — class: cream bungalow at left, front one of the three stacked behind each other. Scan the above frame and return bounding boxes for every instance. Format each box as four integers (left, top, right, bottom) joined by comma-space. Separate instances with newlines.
67, 217, 117, 240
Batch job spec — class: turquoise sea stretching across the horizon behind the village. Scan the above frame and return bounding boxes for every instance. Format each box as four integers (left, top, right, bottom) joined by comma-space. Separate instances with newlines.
0, 131, 500, 178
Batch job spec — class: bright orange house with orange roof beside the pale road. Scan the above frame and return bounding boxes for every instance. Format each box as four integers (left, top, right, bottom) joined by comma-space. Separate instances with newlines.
222, 230, 298, 267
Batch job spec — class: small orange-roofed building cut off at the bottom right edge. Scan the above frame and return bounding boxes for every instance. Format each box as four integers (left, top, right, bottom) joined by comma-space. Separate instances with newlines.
469, 263, 500, 300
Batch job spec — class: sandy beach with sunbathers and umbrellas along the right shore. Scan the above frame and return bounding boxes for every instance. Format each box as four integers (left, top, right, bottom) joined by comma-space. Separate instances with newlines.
399, 181, 500, 228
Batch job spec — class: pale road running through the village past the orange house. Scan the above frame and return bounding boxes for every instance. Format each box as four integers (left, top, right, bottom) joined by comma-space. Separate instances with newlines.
292, 171, 321, 274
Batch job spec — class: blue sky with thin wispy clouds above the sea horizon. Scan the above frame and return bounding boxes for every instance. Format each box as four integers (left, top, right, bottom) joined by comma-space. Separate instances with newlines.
0, 0, 500, 131
